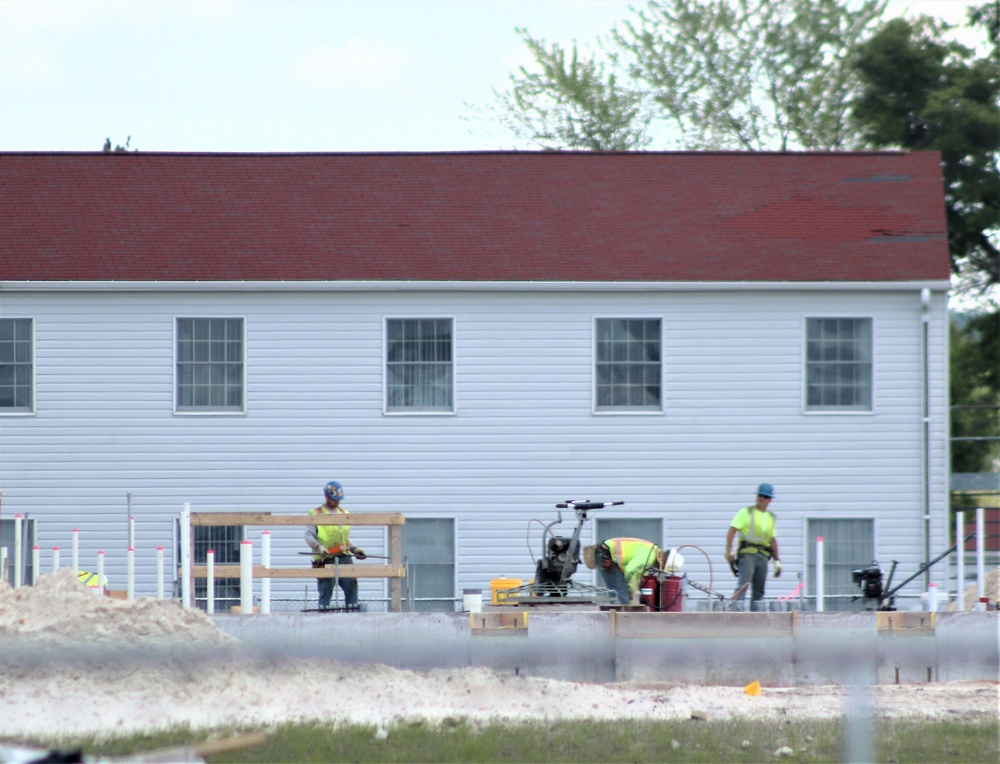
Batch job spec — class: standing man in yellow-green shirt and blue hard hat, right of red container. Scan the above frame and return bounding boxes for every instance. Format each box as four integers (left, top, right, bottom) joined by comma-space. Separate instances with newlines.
725, 483, 781, 612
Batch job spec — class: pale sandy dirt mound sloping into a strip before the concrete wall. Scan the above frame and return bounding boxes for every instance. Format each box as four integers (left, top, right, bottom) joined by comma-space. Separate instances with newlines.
0, 570, 998, 738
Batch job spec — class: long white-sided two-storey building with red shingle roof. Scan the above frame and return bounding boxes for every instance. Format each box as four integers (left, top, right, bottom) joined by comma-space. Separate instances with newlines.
0, 153, 949, 610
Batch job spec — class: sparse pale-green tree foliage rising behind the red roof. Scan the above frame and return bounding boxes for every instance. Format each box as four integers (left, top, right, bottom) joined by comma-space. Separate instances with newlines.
491, 0, 885, 150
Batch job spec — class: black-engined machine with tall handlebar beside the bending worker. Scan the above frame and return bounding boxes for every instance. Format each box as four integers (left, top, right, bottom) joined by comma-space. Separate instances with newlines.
496, 499, 625, 605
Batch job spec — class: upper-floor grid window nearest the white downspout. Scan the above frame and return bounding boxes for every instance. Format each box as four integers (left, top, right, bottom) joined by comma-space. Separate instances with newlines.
805, 318, 873, 411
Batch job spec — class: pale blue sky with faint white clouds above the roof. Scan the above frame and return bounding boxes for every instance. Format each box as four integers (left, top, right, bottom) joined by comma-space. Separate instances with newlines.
0, 0, 984, 152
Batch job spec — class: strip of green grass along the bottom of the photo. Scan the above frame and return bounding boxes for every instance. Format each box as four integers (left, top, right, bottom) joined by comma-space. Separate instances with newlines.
5, 720, 1000, 764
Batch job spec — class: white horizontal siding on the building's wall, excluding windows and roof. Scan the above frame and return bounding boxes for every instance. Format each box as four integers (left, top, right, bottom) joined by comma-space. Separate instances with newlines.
0, 291, 947, 596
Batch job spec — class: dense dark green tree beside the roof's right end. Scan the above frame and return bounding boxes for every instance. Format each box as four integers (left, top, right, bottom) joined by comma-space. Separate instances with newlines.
852, 12, 1000, 293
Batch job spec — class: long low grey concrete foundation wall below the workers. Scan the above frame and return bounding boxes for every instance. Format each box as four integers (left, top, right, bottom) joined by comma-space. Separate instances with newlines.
213, 611, 1000, 686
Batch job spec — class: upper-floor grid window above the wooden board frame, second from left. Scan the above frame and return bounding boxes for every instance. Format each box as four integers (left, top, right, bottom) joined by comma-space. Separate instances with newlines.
177, 318, 244, 412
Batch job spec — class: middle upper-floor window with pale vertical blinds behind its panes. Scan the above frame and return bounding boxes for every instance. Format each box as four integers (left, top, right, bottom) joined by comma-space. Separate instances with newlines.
385, 318, 455, 412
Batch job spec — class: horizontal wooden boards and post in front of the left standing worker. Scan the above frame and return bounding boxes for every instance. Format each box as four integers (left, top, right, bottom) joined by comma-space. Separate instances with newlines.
189, 512, 406, 613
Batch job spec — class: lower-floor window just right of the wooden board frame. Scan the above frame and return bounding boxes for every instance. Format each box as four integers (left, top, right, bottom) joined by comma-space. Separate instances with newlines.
402, 517, 456, 613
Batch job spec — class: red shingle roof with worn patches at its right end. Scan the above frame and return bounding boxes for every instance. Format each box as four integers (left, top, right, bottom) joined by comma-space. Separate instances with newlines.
0, 152, 950, 282
